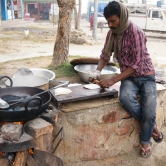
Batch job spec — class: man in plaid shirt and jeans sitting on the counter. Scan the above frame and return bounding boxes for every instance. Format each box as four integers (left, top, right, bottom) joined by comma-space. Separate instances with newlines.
90, 1, 163, 157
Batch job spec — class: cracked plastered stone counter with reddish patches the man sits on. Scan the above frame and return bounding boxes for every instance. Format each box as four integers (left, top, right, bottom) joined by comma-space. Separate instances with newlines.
55, 90, 166, 166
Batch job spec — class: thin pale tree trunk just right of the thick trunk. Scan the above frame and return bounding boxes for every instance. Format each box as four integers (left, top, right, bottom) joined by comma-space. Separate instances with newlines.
74, 0, 82, 29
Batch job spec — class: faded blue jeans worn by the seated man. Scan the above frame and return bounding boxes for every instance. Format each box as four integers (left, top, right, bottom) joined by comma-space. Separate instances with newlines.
119, 75, 156, 144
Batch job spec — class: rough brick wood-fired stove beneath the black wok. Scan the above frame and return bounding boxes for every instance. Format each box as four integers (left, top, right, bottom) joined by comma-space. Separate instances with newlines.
0, 105, 63, 166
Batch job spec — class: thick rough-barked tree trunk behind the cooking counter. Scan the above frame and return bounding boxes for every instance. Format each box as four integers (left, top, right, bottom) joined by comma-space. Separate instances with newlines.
51, 0, 75, 66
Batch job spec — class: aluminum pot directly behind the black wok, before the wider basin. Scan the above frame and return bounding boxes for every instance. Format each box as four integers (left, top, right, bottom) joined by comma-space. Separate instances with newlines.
5, 75, 49, 90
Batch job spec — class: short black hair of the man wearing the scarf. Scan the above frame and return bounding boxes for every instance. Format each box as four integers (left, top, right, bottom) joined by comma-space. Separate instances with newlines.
104, 1, 120, 18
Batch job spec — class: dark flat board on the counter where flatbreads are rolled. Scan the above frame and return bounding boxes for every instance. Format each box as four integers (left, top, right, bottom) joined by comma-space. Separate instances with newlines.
50, 85, 118, 108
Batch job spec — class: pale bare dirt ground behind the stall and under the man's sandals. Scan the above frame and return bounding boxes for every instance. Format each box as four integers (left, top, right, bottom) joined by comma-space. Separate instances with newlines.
0, 20, 166, 166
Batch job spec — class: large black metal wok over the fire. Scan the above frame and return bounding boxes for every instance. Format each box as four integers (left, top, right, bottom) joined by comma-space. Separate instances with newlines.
0, 87, 51, 122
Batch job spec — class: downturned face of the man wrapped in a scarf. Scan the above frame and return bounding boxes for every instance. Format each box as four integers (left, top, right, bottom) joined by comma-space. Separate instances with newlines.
106, 15, 120, 30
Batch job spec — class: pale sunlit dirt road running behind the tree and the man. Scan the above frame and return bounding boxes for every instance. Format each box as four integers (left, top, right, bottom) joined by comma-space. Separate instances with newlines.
0, 20, 166, 65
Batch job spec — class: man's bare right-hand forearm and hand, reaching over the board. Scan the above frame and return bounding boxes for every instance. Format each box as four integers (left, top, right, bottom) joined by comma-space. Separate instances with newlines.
99, 67, 135, 87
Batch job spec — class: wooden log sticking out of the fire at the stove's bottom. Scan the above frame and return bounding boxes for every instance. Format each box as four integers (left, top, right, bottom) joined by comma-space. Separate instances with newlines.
13, 150, 28, 166
